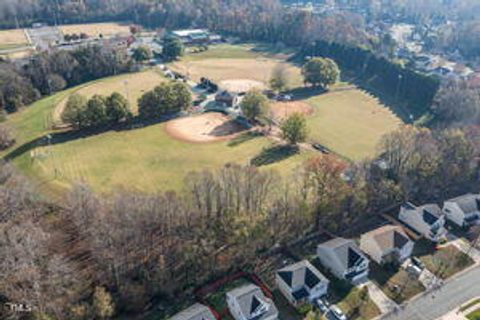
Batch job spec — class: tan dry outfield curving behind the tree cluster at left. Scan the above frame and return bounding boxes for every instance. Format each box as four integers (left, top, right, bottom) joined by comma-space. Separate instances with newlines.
53, 70, 165, 124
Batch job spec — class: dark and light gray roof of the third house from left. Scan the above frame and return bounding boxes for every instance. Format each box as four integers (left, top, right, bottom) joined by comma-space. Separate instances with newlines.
277, 260, 328, 290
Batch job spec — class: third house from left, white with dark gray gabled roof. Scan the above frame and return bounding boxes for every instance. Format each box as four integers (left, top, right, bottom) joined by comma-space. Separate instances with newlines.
275, 260, 330, 305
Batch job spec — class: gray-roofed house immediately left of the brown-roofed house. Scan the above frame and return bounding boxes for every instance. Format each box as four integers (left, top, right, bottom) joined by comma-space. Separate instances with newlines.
317, 238, 369, 284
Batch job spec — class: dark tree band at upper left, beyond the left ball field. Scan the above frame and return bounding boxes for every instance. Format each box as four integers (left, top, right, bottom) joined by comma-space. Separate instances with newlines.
0, 45, 134, 112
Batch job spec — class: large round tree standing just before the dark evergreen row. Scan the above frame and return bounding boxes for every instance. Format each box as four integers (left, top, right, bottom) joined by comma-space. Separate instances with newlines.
302, 58, 340, 89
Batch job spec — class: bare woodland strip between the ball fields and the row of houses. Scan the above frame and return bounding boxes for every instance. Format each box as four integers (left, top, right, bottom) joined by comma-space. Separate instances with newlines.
0, 122, 479, 319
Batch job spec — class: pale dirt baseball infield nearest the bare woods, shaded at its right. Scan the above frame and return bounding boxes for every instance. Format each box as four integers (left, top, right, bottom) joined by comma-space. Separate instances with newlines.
165, 112, 246, 143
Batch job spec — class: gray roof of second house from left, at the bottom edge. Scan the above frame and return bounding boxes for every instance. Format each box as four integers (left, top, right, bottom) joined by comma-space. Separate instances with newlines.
228, 284, 278, 320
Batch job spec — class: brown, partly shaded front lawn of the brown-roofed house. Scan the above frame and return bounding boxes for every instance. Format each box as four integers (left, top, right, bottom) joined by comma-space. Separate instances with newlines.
370, 263, 425, 304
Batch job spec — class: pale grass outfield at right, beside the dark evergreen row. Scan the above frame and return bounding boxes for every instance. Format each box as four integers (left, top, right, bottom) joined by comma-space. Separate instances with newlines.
307, 88, 402, 160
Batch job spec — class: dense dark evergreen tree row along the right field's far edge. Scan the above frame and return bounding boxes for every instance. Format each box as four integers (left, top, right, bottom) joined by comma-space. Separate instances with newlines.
301, 41, 439, 118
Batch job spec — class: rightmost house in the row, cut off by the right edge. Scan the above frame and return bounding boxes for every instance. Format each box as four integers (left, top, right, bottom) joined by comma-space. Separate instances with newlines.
443, 194, 480, 227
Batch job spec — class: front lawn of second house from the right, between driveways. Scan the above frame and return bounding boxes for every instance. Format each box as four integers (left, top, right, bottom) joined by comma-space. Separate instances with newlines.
420, 245, 474, 279
